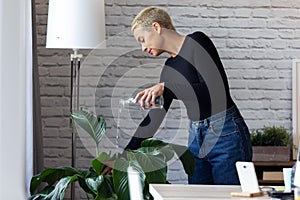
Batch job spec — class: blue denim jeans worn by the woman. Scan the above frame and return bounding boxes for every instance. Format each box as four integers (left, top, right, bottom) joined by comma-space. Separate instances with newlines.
189, 106, 252, 185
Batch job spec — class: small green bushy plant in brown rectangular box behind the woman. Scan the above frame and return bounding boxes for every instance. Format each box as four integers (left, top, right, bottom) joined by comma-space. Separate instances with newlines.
251, 126, 292, 162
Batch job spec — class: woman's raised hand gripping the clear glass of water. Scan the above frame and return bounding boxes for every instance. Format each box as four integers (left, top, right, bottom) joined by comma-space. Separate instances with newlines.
134, 83, 165, 109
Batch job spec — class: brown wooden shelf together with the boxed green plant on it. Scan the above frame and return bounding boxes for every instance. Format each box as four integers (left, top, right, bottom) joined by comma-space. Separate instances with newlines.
251, 126, 294, 185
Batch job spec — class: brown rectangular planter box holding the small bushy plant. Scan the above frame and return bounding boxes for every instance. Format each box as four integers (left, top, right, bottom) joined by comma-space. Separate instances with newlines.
252, 146, 291, 162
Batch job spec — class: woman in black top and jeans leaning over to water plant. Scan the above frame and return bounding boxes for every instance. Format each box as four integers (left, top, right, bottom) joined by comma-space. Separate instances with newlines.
126, 6, 252, 184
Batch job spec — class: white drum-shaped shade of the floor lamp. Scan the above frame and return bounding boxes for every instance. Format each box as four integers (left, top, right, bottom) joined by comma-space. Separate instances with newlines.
46, 0, 105, 49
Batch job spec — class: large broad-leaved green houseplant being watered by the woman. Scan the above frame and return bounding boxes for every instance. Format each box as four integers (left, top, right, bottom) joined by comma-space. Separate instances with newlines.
30, 110, 195, 200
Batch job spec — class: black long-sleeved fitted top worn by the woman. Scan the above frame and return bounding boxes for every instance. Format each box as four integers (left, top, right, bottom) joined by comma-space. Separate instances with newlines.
126, 32, 234, 149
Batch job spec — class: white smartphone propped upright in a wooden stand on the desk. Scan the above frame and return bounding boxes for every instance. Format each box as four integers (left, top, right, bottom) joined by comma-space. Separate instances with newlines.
235, 161, 260, 192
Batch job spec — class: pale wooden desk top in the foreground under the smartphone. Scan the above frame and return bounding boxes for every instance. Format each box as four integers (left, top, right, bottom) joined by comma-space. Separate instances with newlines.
150, 184, 271, 200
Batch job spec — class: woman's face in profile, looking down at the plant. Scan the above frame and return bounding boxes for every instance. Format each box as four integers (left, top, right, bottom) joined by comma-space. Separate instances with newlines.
133, 27, 164, 56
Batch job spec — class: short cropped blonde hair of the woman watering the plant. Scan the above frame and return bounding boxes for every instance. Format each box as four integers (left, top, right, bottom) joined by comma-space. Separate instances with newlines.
131, 6, 175, 31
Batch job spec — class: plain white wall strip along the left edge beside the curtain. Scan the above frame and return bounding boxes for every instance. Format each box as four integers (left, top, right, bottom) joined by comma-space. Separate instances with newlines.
0, 0, 25, 200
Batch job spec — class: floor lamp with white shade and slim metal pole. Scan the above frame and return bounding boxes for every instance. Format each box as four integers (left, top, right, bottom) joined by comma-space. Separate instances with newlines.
46, 0, 105, 199
